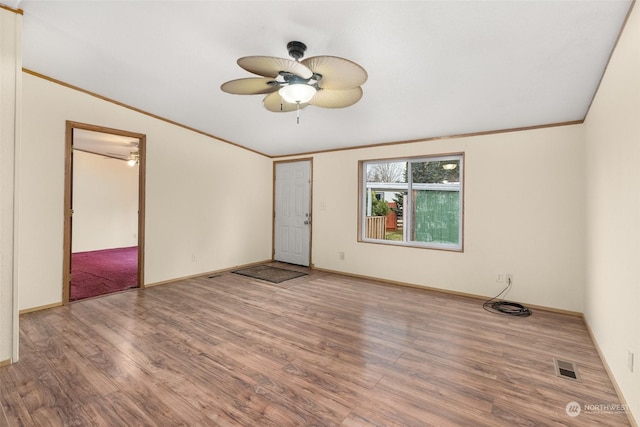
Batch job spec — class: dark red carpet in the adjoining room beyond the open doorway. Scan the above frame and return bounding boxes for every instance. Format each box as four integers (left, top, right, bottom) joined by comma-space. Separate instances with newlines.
69, 246, 138, 301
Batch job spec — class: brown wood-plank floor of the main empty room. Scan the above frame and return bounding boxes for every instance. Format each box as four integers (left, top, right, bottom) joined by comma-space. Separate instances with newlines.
0, 266, 629, 426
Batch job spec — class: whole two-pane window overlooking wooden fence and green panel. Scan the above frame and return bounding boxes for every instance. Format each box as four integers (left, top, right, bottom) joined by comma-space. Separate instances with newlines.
359, 154, 464, 251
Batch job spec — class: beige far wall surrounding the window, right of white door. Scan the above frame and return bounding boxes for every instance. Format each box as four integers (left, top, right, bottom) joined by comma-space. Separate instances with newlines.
282, 125, 585, 312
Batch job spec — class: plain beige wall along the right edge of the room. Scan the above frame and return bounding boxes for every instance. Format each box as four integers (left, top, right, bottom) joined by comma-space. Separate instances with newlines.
585, 4, 640, 420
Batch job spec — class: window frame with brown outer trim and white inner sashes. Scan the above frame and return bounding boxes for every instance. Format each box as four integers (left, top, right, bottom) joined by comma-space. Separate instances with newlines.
358, 152, 465, 252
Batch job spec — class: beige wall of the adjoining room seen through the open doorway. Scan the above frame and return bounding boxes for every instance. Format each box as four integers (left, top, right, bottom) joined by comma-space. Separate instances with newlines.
71, 150, 139, 252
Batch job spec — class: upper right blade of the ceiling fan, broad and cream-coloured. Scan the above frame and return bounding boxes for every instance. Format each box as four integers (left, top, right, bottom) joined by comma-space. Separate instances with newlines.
302, 56, 368, 89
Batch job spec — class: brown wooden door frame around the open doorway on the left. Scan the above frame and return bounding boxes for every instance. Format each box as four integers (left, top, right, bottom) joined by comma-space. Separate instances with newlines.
62, 120, 147, 304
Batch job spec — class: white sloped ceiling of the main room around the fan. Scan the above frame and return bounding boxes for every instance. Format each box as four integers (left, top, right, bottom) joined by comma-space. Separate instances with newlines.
8, 0, 632, 156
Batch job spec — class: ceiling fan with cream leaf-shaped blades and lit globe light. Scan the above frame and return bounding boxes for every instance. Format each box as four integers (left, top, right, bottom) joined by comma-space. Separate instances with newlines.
220, 41, 367, 121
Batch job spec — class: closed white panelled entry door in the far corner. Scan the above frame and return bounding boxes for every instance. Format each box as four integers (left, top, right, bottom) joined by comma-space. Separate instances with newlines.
274, 160, 311, 266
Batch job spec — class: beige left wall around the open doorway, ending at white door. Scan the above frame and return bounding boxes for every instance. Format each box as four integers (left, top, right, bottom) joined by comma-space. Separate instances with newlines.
18, 74, 272, 309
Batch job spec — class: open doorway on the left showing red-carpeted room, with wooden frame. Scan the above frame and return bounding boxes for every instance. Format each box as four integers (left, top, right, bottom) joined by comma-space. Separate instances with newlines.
63, 121, 146, 304
